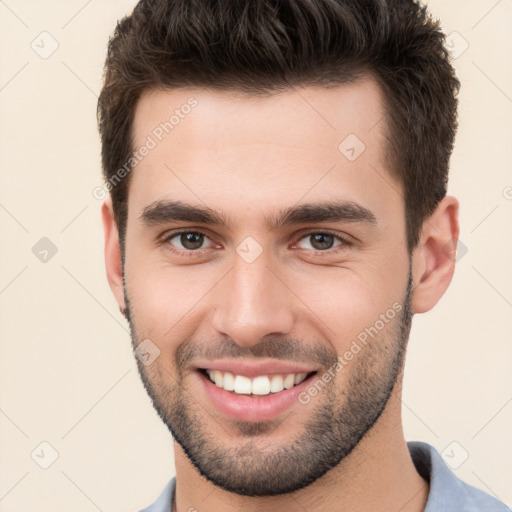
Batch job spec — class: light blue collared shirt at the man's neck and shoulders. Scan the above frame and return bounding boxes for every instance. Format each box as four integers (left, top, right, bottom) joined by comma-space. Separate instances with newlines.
140, 441, 512, 512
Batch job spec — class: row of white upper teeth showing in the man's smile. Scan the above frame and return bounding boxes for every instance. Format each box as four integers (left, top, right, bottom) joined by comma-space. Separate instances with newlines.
206, 370, 307, 396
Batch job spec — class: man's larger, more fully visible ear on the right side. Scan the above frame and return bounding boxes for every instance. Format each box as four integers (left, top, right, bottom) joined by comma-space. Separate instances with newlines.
411, 196, 459, 313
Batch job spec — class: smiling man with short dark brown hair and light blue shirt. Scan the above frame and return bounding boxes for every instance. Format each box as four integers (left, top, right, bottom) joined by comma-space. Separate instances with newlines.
98, 0, 508, 512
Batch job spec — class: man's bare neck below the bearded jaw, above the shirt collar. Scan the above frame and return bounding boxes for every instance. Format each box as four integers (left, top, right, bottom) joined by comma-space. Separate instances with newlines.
173, 389, 429, 512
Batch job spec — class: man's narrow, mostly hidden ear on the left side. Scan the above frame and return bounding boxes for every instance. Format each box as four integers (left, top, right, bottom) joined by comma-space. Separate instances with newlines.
101, 196, 126, 315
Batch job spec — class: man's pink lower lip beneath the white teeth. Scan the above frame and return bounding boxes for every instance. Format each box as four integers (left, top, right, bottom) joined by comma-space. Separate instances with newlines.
197, 371, 316, 422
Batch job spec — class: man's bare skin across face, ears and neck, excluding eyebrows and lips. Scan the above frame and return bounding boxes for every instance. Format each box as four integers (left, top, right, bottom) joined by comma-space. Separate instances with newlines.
102, 78, 459, 512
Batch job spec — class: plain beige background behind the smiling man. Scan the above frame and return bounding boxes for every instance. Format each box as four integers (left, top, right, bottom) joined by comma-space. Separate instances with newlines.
0, 0, 512, 512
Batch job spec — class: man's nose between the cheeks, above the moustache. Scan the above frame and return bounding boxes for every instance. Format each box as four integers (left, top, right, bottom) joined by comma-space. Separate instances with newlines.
213, 254, 295, 346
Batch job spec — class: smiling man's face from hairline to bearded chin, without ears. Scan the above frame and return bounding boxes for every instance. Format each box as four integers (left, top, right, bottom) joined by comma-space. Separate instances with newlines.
120, 80, 412, 496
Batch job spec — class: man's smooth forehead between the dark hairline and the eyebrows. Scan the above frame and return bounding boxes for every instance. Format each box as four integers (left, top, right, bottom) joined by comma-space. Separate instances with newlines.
129, 79, 401, 230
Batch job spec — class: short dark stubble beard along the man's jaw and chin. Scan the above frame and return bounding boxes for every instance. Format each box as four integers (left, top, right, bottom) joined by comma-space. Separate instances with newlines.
125, 265, 413, 496
